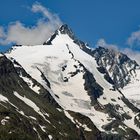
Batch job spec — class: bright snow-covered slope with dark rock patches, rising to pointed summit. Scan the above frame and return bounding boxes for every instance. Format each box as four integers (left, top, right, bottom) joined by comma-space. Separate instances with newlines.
6, 25, 140, 139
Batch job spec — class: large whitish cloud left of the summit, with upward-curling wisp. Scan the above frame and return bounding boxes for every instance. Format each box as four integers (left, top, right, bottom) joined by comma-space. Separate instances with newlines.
0, 3, 62, 45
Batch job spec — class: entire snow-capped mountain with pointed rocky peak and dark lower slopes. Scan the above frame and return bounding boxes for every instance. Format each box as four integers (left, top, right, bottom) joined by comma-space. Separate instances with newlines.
0, 25, 140, 140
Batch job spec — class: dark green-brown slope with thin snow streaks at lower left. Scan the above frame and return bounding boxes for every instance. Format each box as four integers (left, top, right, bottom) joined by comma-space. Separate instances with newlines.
0, 55, 103, 140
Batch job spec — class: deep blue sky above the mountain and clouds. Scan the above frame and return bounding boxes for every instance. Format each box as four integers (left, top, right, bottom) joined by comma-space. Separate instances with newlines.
0, 0, 140, 58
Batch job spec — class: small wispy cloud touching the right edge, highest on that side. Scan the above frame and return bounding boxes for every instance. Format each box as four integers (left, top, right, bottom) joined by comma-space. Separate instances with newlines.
127, 30, 140, 46
